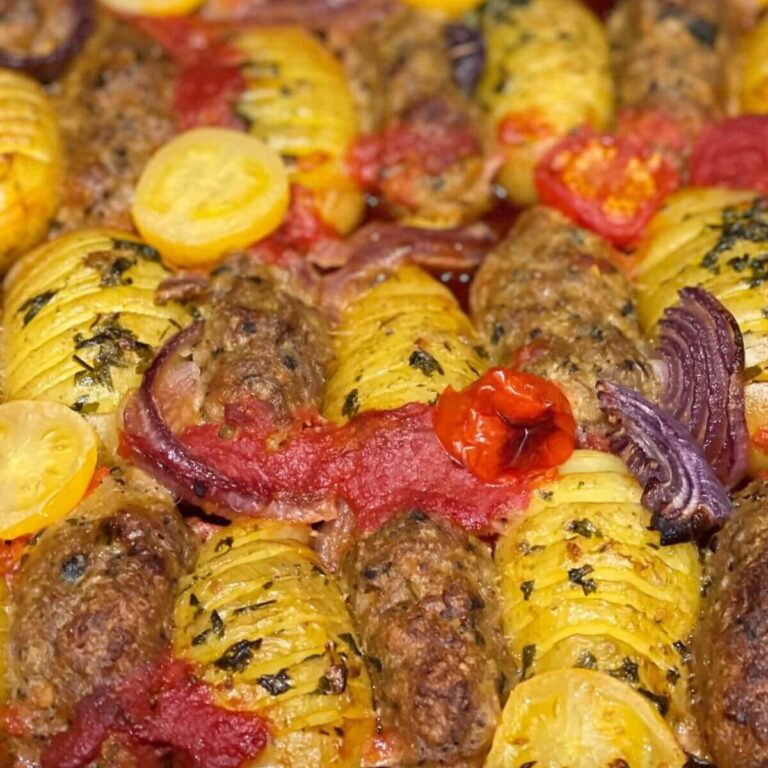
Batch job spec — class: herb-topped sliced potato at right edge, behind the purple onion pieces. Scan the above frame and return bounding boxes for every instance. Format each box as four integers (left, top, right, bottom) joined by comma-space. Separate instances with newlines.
636, 189, 768, 473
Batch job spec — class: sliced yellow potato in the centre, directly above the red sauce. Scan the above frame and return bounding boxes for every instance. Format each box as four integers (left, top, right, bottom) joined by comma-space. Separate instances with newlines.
323, 265, 486, 421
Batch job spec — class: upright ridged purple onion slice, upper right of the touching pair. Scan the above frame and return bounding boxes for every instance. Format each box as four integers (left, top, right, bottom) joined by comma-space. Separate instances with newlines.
658, 288, 749, 489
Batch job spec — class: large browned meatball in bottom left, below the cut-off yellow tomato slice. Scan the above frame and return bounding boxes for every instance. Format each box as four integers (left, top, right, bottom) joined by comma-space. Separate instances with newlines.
10, 480, 196, 760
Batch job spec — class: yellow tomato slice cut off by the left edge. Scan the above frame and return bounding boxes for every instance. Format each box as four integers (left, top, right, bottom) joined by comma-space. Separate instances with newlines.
0, 400, 98, 539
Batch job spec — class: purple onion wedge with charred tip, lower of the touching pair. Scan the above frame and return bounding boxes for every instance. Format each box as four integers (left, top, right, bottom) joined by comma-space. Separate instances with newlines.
597, 381, 731, 544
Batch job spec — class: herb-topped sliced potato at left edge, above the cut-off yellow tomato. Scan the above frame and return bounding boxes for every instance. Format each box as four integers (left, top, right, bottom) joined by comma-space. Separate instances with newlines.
3, 230, 189, 413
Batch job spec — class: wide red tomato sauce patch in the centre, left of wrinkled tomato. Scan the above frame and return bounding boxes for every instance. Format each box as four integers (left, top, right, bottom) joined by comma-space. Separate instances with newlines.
176, 403, 530, 532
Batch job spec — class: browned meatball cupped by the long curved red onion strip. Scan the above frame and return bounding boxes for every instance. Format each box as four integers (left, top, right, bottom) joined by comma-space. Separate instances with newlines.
194, 257, 333, 424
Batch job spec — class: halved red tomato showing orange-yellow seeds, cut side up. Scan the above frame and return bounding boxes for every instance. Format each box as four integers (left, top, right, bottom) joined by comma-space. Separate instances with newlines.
536, 129, 678, 246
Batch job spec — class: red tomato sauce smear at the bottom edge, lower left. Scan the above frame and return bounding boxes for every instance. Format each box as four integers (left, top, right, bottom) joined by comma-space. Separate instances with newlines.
42, 657, 269, 768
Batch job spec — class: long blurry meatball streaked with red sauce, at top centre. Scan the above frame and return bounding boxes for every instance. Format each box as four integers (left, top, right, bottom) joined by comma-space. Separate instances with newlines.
340, 9, 491, 227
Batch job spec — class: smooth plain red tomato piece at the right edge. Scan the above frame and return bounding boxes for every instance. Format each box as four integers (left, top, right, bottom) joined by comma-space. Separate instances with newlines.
690, 115, 768, 192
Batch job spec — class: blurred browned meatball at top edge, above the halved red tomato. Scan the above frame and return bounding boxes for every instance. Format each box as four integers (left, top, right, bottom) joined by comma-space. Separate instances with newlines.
608, 0, 724, 139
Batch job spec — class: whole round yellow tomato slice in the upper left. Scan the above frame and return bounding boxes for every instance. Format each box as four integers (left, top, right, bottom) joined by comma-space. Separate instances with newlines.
132, 128, 289, 267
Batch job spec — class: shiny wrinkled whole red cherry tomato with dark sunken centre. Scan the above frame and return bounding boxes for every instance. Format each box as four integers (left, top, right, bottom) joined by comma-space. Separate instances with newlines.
432, 368, 576, 483
